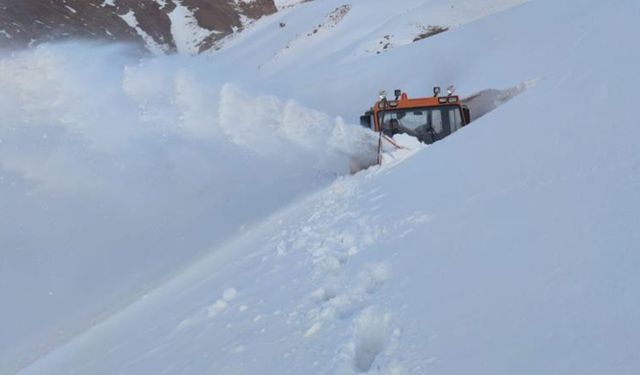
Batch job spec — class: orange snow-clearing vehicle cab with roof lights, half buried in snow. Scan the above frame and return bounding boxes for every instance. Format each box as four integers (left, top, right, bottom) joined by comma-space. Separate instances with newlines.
360, 87, 471, 144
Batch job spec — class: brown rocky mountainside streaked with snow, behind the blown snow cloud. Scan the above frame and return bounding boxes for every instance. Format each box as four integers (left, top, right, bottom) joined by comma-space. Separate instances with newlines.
0, 0, 276, 54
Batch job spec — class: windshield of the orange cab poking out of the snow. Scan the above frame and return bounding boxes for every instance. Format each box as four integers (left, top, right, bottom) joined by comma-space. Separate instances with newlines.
378, 105, 463, 143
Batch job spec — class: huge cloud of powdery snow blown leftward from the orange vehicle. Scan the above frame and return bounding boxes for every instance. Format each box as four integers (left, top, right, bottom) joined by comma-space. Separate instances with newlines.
0, 43, 375, 370
